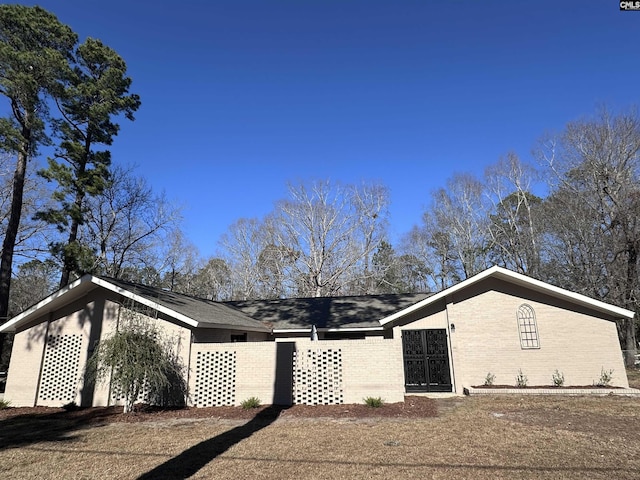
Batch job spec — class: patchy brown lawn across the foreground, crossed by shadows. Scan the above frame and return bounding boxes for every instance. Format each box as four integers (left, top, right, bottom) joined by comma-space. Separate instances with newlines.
0, 395, 640, 480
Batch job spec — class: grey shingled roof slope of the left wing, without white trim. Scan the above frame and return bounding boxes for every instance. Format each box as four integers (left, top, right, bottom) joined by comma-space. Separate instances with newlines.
99, 277, 269, 331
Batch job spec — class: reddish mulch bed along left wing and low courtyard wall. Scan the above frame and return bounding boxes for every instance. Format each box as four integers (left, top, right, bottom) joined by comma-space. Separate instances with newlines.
0, 397, 438, 425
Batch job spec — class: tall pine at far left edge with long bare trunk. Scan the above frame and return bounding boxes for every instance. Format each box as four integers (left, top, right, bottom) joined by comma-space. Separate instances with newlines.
0, 5, 77, 368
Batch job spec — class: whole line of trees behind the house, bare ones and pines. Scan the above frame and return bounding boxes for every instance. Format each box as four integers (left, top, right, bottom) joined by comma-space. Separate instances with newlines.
0, 5, 640, 364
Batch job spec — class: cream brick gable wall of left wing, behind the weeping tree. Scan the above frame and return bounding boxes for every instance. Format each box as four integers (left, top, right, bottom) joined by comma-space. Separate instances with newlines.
5, 291, 191, 407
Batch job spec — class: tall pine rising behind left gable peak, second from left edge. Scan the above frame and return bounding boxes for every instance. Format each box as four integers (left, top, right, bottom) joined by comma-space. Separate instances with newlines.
37, 38, 140, 287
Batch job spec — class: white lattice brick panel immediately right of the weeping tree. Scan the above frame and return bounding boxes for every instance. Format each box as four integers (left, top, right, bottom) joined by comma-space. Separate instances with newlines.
194, 351, 236, 407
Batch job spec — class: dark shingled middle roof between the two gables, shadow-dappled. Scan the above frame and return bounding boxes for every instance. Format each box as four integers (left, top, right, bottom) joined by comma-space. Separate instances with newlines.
224, 293, 431, 329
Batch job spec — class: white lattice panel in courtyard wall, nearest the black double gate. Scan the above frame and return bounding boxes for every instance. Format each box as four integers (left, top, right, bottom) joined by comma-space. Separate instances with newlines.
293, 348, 344, 405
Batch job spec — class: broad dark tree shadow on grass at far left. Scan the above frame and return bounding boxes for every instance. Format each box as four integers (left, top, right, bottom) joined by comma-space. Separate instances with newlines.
0, 408, 117, 450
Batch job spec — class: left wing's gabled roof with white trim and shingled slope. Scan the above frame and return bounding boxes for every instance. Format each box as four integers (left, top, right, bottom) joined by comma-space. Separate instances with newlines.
0, 275, 271, 332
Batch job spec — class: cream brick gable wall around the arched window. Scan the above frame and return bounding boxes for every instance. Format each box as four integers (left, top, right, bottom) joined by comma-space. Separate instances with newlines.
394, 280, 628, 394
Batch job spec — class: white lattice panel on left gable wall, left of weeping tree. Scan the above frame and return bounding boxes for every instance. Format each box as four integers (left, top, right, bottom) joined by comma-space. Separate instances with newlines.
38, 335, 82, 404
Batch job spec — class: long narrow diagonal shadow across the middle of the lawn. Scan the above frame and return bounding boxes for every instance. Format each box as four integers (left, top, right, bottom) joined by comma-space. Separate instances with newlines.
138, 405, 289, 480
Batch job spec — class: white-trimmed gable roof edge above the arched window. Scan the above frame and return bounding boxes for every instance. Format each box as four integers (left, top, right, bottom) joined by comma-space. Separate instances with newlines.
380, 266, 635, 325
